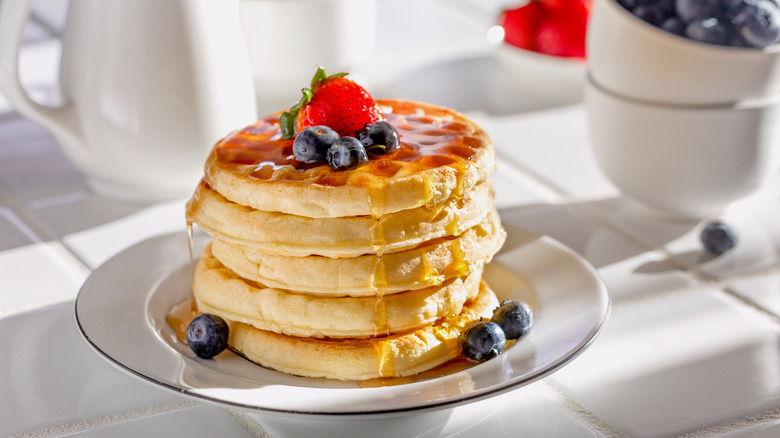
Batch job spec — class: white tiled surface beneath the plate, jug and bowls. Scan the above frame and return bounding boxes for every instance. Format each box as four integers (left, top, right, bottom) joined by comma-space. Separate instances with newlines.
0, 0, 780, 438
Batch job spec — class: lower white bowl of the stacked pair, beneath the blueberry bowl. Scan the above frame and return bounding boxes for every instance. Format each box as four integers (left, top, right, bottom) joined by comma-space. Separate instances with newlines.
585, 74, 780, 219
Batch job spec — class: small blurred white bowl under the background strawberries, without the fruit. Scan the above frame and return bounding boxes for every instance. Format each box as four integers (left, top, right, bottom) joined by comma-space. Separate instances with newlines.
488, 25, 587, 100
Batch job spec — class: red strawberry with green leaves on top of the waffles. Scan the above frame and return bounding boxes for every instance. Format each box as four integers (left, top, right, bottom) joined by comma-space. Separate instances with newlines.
279, 67, 385, 139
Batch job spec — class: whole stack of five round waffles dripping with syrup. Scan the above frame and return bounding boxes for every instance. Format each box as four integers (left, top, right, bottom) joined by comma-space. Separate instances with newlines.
187, 100, 505, 380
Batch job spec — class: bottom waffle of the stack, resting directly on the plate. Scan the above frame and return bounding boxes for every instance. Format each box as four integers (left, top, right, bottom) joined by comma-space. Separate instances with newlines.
228, 282, 498, 380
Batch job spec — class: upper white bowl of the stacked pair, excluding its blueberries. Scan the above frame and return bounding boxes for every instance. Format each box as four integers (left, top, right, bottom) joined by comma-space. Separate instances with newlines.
587, 0, 780, 105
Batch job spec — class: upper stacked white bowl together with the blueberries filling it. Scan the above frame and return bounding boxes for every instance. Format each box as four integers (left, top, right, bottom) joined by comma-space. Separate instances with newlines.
587, 0, 780, 105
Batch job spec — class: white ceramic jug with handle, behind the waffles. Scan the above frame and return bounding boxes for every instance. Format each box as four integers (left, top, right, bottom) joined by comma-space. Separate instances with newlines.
0, 0, 256, 201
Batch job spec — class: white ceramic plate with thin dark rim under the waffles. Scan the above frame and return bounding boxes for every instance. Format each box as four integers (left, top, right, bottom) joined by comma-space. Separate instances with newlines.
76, 230, 609, 417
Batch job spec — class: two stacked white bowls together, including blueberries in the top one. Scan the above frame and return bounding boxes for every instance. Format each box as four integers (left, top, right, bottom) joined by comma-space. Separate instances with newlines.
584, 0, 780, 219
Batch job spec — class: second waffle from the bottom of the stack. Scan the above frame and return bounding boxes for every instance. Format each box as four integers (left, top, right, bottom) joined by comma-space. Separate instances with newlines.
193, 245, 482, 338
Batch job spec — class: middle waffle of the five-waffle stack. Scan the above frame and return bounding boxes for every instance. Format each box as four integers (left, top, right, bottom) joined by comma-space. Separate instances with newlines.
212, 210, 506, 297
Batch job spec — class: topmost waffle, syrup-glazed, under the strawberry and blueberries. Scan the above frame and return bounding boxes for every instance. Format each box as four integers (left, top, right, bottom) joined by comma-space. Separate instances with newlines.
205, 100, 495, 218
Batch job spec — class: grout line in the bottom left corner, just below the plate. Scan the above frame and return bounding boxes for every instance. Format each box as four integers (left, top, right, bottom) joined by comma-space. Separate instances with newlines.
9, 399, 201, 438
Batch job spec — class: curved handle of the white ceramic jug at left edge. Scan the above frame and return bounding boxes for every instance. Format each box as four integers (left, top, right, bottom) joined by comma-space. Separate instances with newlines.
0, 0, 88, 164
